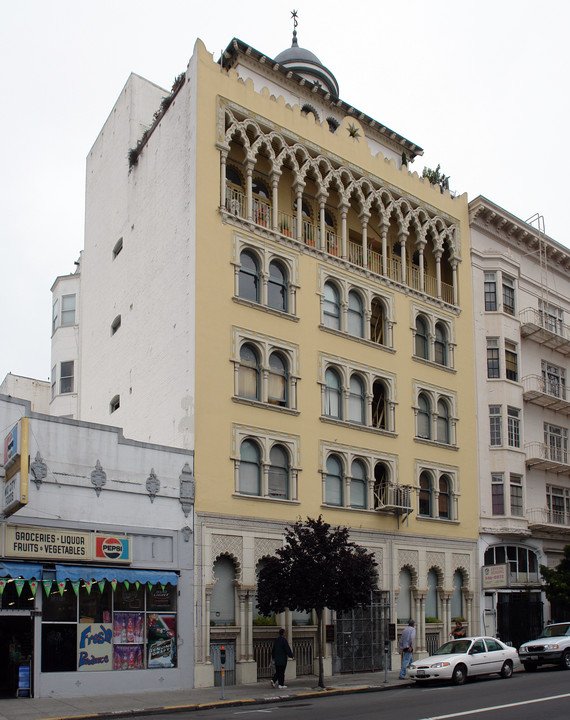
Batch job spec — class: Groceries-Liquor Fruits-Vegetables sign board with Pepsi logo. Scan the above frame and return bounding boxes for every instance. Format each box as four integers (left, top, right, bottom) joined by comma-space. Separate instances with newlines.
4, 525, 132, 564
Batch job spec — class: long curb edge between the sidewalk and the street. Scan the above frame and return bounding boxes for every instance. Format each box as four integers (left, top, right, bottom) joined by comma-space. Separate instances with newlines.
33, 680, 413, 720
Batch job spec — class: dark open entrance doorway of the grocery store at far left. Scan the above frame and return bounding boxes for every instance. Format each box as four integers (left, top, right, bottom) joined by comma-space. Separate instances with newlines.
0, 615, 34, 698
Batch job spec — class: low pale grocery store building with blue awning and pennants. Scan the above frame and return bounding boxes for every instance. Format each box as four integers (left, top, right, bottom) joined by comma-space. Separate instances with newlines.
0, 396, 194, 697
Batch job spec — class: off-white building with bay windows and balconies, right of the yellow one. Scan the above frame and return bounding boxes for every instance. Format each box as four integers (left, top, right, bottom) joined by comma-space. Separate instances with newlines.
469, 197, 570, 646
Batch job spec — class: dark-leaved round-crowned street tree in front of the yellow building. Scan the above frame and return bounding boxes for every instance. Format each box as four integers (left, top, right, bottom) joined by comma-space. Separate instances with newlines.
257, 516, 378, 687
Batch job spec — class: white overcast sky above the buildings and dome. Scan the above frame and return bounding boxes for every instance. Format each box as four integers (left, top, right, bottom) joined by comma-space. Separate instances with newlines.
0, 0, 570, 388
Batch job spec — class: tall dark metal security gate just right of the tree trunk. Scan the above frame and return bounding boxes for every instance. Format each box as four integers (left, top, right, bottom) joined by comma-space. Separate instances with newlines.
336, 590, 390, 673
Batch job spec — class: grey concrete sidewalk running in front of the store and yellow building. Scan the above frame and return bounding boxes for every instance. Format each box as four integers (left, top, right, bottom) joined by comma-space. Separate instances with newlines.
0, 670, 412, 720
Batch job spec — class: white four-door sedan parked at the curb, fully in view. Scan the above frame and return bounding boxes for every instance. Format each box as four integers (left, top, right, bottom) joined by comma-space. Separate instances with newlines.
408, 637, 520, 685
